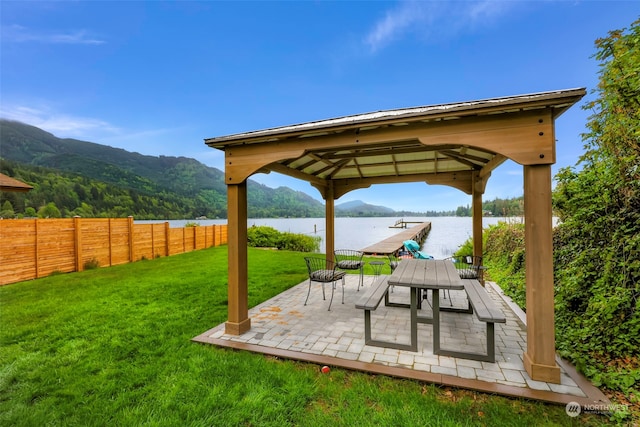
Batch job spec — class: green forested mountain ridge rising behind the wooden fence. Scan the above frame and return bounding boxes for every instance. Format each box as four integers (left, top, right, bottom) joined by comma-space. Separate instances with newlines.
0, 120, 324, 219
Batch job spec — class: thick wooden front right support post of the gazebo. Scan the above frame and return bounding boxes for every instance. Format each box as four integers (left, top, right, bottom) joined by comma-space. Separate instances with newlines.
524, 165, 560, 384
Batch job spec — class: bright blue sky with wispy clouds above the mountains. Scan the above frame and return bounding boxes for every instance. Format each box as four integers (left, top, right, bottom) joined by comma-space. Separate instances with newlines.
0, 0, 640, 211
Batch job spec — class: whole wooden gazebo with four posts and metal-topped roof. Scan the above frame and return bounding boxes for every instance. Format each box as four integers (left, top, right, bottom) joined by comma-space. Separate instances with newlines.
205, 88, 586, 383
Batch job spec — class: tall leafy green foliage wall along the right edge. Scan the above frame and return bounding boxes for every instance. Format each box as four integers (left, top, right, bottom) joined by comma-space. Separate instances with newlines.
554, 20, 640, 394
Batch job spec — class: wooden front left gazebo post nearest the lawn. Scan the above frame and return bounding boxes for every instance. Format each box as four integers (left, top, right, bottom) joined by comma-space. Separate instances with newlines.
225, 180, 251, 335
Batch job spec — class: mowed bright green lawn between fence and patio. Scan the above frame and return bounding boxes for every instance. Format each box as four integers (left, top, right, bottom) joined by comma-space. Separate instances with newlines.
0, 247, 606, 426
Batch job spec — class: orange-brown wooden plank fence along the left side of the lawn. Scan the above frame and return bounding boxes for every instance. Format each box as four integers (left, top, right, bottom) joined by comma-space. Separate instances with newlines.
0, 217, 227, 285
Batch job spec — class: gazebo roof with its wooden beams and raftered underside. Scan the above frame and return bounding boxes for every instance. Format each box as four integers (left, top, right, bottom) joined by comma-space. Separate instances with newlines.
205, 88, 585, 199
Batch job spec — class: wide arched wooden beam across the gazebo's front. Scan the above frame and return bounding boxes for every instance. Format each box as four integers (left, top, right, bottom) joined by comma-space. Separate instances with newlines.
225, 109, 555, 184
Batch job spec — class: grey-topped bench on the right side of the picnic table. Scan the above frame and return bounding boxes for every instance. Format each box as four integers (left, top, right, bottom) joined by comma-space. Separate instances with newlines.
438, 279, 507, 363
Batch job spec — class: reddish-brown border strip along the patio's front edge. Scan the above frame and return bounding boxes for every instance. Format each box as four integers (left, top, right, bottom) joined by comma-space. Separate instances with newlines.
192, 328, 609, 406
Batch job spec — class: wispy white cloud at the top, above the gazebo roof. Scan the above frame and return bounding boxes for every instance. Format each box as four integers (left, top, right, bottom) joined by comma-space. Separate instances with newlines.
364, 0, 517, 53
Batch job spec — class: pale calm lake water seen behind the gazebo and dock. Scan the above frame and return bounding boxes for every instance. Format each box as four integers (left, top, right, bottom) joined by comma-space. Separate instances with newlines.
136, 217, 520, 259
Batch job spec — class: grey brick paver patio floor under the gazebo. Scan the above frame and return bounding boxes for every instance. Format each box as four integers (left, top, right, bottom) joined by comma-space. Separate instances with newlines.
194, 275, 609, 405
